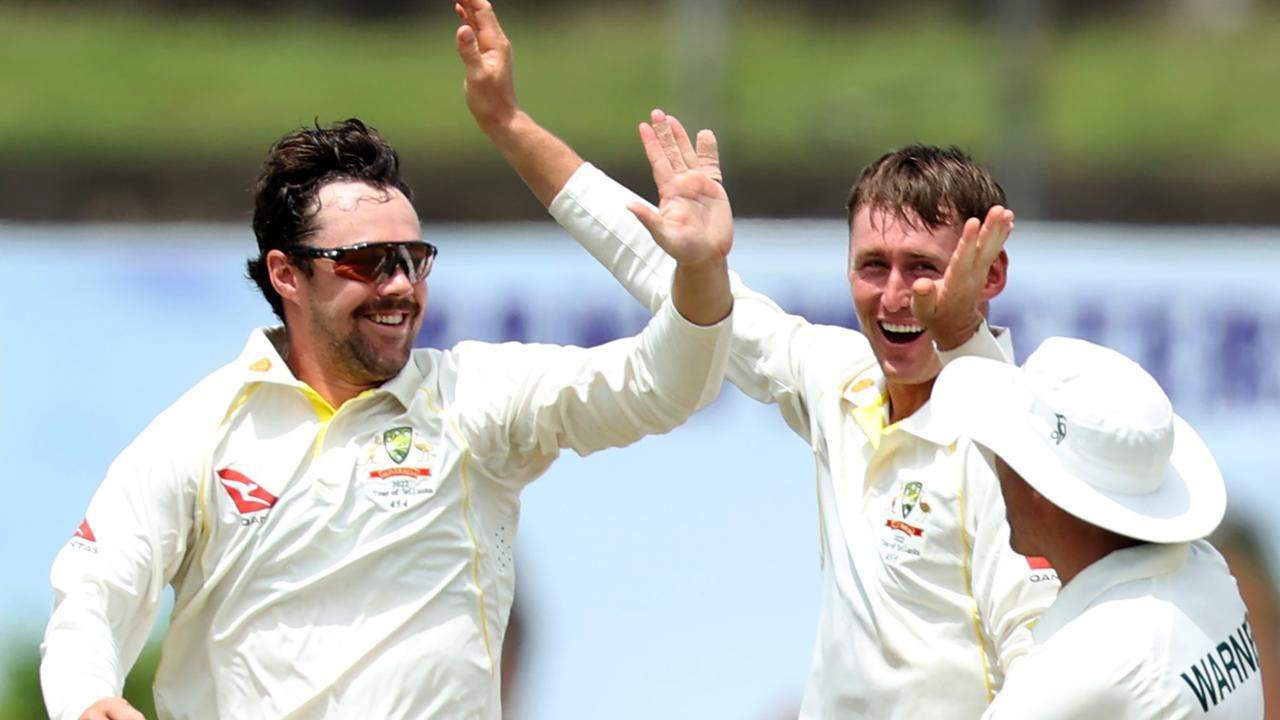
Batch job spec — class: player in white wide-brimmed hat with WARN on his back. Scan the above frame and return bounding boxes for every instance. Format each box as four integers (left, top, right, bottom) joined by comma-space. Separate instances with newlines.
933, 338, 1262, 720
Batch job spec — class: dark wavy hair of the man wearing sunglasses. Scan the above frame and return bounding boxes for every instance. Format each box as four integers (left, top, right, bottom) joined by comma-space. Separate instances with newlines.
246, 118, 413, 322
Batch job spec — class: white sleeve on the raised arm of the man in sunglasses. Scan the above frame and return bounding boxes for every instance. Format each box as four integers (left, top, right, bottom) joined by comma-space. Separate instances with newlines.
458, 294, 733, 457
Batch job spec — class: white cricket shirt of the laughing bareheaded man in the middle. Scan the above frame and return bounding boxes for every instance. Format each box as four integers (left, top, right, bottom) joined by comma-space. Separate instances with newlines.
550, 164, 1057, 720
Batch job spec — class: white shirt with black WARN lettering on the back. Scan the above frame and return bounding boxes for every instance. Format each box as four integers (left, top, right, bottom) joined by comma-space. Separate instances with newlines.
983, 541, 1262, 720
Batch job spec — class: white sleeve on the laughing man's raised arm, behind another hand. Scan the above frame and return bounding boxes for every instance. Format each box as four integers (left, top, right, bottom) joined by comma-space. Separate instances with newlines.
549, 164, 873, 439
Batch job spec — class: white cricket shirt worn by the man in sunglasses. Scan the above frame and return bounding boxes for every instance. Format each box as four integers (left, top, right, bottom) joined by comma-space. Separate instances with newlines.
41, 298, 731, 720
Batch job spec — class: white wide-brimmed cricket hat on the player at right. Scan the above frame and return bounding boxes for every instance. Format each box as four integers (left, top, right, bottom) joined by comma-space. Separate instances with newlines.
931, 337, 1226, 542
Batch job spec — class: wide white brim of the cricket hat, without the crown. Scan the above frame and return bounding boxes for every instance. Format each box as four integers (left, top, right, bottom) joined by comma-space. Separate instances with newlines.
931, 357, 1226, 543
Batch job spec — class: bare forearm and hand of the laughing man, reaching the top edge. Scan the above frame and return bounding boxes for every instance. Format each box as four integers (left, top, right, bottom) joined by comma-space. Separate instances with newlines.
453, 0, 582, 206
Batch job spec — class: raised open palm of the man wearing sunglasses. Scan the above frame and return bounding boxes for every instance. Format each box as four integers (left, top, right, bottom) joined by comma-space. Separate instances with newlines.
627, 110, 733, 264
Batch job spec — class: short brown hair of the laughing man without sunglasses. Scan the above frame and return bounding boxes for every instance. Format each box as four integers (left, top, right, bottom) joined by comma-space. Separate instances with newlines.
846, 145, 1006, 229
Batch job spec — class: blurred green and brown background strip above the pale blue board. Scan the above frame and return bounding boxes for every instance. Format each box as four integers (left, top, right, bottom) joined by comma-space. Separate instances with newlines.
0, 0, 1280, 223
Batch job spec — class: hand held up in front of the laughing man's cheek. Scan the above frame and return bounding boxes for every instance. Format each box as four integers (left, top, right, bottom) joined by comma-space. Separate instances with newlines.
911, 205, 1014, 350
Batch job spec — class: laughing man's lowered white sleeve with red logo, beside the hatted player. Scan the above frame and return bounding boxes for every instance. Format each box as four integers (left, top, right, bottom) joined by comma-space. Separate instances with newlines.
961, 441, 1059, 676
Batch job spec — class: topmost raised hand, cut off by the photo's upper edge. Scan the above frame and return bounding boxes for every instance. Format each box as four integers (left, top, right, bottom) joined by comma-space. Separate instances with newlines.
453, 0, 520, 132
